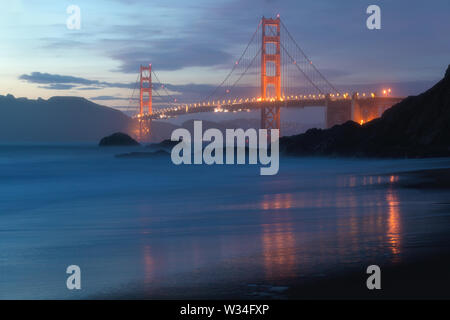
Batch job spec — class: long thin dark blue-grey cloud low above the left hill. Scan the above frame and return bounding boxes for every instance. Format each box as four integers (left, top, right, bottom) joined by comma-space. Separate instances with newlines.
19, 72, 135, 90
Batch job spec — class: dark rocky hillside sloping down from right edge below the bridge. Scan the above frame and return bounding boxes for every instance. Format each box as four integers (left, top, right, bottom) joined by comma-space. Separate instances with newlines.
280, 66, 450, 157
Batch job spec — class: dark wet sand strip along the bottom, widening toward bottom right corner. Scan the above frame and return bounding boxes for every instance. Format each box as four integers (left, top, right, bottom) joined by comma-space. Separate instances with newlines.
103, 247, 450, 300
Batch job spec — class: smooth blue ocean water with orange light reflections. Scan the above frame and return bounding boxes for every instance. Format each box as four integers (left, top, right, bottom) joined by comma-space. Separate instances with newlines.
0, 146, 450, 299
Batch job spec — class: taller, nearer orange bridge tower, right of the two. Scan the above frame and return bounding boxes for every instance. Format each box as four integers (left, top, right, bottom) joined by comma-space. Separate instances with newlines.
261, 17, 281, 129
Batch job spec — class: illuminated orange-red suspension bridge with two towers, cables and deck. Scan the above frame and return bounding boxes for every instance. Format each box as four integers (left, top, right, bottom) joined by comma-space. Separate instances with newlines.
125, 16, 403, 140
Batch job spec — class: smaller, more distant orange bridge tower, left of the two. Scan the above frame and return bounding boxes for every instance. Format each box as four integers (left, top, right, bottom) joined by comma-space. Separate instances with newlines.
138, 64, 153, 141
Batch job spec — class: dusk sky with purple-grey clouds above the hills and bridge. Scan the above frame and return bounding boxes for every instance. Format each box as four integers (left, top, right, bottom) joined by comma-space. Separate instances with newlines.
0, 0, 450, 110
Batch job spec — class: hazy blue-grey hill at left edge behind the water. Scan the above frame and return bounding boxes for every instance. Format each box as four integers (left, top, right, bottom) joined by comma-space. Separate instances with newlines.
0, 95, 132, 142
